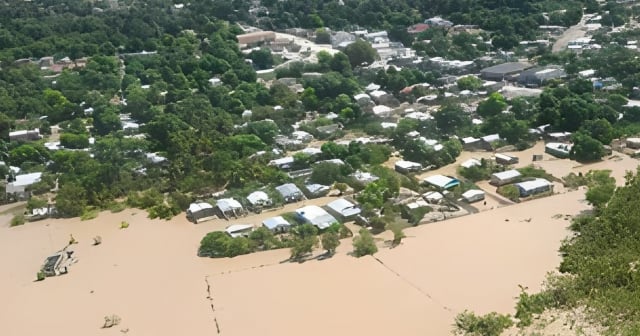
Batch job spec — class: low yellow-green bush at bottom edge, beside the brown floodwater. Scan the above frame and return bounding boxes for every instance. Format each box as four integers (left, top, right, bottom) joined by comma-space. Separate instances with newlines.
455, 311, 513, 336
